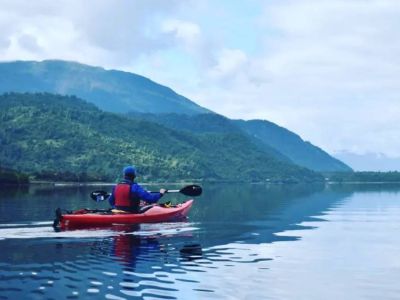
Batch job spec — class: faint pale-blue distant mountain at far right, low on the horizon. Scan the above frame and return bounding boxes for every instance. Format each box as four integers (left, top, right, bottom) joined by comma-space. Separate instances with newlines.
334, 151, 400, 172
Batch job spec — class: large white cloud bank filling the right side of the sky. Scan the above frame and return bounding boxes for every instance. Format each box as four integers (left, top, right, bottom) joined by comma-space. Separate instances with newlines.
185, 0, 400, 155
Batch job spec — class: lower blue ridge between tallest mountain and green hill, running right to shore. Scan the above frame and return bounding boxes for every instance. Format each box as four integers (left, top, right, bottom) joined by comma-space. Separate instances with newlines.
130, 113, 352, 172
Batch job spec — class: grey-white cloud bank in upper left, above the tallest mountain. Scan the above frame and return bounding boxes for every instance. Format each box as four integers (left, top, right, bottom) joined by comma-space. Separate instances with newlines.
0, 0, 184, 67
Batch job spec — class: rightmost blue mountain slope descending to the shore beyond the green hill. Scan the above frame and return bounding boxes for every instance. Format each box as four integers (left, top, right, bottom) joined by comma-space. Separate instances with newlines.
234, 120, 352, 172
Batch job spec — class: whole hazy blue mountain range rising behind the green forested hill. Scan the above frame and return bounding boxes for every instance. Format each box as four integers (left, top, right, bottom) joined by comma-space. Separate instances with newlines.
0, 60, 351, 172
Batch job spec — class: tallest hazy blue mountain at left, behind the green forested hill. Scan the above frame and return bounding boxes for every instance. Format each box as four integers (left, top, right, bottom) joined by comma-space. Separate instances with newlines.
0, 60, 210, 115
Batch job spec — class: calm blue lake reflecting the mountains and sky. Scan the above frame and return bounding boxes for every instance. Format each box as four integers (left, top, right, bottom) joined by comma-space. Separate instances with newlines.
0, 184, 400, 299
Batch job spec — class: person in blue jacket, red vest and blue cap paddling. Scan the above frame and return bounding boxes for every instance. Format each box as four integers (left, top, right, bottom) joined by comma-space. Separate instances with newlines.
108, 166, 167, 213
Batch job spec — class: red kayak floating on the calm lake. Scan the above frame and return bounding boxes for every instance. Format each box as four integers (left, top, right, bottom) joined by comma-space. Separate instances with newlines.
54, 199, 193, 230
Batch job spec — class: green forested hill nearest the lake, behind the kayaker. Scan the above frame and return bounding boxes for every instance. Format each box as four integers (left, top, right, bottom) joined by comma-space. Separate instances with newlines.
0, 93, 322, 182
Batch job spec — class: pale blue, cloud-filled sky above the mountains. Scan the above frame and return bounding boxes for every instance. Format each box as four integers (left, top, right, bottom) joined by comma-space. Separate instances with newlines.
0, 0, 400, 157
